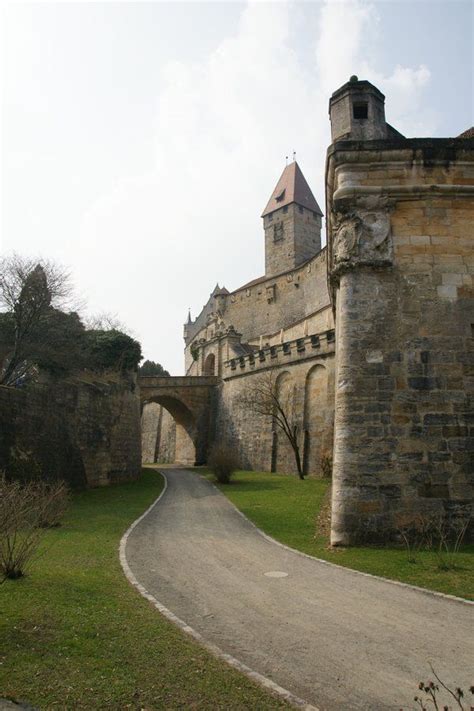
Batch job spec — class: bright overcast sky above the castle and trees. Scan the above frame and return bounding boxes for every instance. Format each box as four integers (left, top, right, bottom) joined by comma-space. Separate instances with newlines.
1, 0, 474, 375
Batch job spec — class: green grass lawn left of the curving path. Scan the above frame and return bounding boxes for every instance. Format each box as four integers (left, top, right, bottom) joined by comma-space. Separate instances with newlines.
0, 470, 288, 710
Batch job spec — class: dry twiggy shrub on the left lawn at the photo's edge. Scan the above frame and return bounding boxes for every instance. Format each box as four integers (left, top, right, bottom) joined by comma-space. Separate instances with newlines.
0, 474, 68, 579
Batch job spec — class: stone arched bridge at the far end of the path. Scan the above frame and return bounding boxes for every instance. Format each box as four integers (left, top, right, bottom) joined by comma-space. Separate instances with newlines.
138, 375, 221, 464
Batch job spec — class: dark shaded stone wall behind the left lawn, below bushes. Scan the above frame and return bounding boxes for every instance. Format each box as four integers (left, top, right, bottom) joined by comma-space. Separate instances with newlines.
0, 378, 141, 488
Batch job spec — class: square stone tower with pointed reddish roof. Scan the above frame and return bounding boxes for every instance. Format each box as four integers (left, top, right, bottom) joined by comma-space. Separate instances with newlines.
262, 161, 322, 277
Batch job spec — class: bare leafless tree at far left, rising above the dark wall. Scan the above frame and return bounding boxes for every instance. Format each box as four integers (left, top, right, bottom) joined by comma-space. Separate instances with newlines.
0, 254, 72, 385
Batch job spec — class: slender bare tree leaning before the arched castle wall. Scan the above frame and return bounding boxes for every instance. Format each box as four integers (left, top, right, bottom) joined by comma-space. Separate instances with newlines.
240, 368, 304, 479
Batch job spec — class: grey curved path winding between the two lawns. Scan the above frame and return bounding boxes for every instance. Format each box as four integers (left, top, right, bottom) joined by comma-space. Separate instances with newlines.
125, 469, 474, 711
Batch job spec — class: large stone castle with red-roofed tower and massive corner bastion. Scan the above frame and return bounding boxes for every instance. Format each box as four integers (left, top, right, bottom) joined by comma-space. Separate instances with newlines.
143, 77, 474, 545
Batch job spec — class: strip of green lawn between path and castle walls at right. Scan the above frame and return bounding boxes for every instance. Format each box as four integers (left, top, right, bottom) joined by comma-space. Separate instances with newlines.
202, 472, 474, 600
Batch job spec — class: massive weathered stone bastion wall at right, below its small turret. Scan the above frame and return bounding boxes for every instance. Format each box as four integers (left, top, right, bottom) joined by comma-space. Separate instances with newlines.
329, 139, 474, 544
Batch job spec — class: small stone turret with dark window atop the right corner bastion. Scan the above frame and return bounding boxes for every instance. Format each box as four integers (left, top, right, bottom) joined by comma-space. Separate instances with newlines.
329, 76, 390, 143
